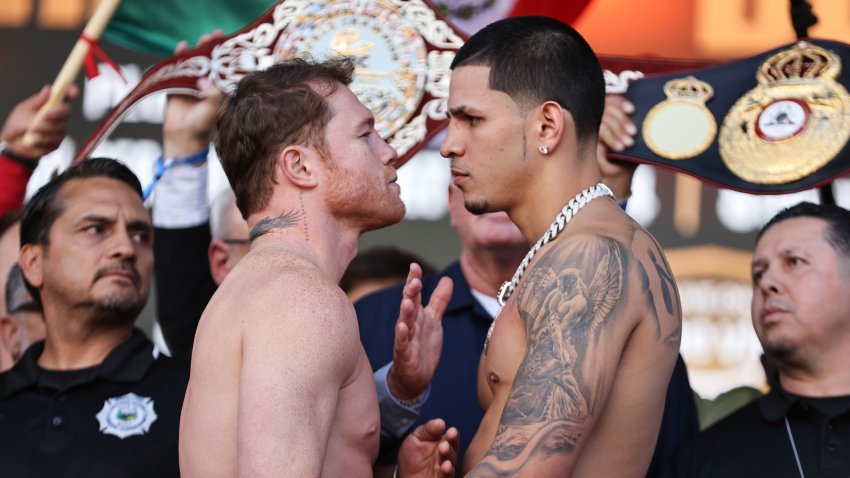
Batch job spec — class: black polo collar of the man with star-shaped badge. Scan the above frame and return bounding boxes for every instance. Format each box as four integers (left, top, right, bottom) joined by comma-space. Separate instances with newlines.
0, 329, 155, 399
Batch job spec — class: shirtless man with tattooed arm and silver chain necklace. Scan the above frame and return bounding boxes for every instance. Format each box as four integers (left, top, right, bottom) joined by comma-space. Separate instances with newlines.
441, 17, 681, 477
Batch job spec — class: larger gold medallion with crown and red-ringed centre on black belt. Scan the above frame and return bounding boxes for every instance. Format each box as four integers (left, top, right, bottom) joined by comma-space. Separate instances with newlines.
718, 42, 850, 184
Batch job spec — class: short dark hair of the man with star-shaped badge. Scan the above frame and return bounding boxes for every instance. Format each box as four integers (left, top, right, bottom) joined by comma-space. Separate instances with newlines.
21, 158, 142, 246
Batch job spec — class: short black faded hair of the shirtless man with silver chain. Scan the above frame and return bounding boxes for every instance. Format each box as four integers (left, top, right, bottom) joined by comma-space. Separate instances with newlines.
451, 17, 605, 144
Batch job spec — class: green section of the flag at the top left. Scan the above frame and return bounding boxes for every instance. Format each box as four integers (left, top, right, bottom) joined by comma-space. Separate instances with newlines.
103, 0, 275, 57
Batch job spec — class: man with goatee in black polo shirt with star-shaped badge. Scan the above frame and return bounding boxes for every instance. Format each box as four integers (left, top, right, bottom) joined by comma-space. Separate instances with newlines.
0, 158, 188, 477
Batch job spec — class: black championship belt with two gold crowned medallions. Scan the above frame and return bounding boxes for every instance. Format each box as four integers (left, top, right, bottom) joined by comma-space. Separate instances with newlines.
611, 40, 850, 194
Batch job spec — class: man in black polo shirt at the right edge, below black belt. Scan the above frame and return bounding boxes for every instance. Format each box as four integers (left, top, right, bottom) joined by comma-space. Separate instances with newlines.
675, 203, 850, 478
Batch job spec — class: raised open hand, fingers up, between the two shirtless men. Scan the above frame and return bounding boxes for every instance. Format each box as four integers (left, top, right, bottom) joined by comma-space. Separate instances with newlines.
387, 263, 453, 400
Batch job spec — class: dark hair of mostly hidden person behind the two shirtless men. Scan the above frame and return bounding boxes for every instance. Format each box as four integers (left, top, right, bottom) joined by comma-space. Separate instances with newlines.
339, 246, 437, 293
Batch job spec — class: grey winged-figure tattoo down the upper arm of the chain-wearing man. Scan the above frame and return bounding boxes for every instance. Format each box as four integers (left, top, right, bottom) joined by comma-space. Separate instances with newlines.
480, 237, 628, 472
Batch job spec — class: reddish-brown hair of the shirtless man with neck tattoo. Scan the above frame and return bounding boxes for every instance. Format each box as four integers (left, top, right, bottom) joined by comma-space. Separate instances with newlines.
216, 58, 354, 219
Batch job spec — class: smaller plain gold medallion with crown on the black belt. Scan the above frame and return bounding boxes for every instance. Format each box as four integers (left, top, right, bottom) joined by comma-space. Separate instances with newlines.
641, 76, 717, 159
